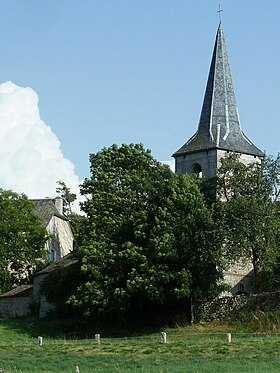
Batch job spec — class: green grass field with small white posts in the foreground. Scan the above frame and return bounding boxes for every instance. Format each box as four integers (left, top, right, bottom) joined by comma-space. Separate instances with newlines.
0, 320, 280, 373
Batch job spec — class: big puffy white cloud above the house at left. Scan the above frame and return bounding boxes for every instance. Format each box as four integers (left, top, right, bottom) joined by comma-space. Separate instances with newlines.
0, 82, 79, 211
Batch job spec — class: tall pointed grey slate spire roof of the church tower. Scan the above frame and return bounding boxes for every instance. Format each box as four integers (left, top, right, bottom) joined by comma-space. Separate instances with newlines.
173, 22, 264, 157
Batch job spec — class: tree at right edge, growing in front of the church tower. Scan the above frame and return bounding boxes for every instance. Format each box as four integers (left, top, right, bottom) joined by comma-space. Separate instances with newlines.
214, 154, 280, 290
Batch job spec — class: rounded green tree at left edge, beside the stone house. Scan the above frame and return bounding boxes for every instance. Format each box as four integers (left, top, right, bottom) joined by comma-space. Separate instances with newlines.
0, 189, 48, 293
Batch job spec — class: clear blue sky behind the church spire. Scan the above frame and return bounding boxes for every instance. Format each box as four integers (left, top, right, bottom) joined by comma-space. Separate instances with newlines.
0, 0, 280, 179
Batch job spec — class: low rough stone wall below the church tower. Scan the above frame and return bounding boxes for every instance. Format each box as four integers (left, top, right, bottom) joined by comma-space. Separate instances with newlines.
198, 291, 280, 321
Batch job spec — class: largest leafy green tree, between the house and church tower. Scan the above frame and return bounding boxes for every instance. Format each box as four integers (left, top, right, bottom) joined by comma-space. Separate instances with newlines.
70, 144, 223, 315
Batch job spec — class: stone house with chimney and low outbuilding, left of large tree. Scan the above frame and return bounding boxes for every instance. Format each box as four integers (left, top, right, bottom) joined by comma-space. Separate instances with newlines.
0, 197, 74, 317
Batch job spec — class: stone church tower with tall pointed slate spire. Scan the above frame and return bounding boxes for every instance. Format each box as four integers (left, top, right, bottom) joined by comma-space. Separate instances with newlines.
173, 22, 264, 294
